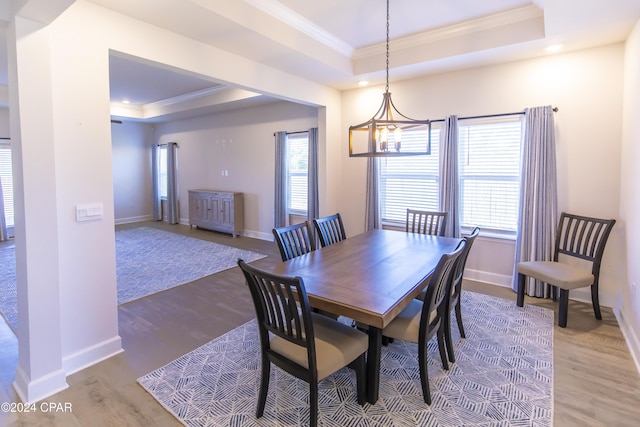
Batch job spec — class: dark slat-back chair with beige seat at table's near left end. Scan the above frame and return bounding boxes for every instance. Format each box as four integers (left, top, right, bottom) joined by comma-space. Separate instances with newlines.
238, 259, 369, 426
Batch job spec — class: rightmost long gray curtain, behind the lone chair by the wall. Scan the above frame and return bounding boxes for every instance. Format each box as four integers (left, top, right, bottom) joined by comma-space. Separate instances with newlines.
512, 106, 558, 298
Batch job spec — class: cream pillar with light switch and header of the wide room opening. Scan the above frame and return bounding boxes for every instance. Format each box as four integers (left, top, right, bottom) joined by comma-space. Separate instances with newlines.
8, 1, 340, 402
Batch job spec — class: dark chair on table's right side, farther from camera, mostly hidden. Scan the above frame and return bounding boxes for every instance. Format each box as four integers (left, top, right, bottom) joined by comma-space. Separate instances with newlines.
444, 227, 480, 363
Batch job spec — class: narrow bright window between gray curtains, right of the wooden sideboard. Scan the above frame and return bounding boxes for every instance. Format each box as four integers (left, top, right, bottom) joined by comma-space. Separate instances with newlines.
287, 132, 309, 216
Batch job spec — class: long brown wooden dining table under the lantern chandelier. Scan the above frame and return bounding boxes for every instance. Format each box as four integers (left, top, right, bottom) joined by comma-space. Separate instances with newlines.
256, 229, 460, 404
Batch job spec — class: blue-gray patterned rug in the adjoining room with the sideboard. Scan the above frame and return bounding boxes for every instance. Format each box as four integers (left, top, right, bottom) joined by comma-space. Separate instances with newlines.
0, 227, 266, 332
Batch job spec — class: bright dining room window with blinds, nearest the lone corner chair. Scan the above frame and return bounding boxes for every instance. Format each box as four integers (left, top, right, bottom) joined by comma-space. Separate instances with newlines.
458, 116, 522, 234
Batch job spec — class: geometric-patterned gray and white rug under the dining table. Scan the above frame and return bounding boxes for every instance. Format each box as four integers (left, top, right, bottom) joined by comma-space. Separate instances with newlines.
138, 292, 553, 427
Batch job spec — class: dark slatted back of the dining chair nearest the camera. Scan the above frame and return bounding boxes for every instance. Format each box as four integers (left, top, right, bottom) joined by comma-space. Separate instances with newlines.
238, 260, 315, 351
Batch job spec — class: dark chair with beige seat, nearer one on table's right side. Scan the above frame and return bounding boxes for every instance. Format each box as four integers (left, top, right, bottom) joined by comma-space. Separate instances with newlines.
382, 240, 467, 405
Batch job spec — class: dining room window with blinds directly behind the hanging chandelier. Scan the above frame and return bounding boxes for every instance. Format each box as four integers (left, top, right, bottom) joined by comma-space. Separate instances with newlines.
379, 127, 440, 225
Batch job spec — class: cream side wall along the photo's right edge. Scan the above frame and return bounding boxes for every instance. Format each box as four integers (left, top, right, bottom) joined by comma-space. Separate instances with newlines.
617, 21, 640, 369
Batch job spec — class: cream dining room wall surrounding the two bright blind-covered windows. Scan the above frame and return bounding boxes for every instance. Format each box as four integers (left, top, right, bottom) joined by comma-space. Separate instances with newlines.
340, 44, 624, 306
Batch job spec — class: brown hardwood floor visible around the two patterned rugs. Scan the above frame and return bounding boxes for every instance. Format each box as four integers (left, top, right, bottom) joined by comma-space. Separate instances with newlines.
0, 222, 640, 427
